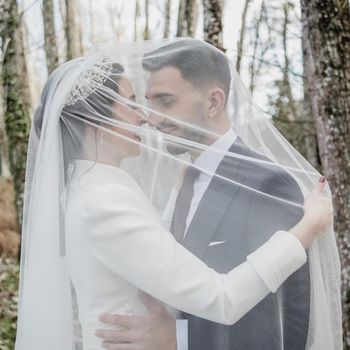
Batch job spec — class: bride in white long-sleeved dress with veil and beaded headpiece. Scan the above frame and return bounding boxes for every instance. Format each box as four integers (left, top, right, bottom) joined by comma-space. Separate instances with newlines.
16, 39, 340, 350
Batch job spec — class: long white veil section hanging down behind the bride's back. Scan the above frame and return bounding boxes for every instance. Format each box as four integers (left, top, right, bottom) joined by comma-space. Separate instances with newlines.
16, 59, 83, 350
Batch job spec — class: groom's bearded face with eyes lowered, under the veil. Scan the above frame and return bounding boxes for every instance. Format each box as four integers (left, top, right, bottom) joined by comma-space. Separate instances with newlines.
146, 66, 207, 154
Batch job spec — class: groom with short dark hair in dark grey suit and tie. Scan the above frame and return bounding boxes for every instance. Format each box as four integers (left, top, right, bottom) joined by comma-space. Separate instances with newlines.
95, 40, 310, 350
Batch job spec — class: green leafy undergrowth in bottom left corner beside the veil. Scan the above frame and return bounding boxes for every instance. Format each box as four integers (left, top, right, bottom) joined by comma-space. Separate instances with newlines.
0, 259, 19, 350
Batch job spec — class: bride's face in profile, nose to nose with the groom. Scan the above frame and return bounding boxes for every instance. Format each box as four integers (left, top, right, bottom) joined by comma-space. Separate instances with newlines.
106, 77, 146, 157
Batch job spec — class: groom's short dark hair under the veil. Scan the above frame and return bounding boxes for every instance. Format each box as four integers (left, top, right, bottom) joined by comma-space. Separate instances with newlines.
142, 39, 231, 103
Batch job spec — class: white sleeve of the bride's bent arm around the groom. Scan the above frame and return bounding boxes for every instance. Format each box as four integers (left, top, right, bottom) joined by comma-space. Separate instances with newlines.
84, 185, 314, 324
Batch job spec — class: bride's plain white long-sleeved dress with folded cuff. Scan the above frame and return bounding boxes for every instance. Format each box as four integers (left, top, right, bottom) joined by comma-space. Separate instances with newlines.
66, 160, 306, 350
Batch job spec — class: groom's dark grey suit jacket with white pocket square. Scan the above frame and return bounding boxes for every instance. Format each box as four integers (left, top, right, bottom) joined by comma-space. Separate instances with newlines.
182, 138, 310, 350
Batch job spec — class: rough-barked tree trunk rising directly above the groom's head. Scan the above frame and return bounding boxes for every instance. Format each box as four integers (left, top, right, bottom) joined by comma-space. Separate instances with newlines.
203, 0, 224, 51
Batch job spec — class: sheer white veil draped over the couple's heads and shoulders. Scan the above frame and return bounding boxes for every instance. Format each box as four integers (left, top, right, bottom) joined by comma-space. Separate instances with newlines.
16, 39, 342, 350
